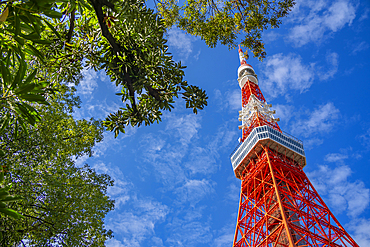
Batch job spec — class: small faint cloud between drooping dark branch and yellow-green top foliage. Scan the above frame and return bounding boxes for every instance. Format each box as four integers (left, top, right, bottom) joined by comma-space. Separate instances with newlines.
167, 29, 195, 60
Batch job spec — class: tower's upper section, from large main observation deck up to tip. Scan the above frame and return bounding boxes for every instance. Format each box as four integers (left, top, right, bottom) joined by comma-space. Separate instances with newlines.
231, 47, 306, 179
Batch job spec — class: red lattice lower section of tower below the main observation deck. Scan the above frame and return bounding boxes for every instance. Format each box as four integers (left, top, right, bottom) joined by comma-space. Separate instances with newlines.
233, 142, 358, 247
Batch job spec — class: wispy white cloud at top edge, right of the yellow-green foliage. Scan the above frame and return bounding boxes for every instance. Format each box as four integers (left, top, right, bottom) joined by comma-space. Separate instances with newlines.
288, 0, 356, 46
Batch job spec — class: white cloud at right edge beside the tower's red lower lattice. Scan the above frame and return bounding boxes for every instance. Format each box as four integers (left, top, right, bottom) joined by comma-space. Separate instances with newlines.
307, 165, 370, 217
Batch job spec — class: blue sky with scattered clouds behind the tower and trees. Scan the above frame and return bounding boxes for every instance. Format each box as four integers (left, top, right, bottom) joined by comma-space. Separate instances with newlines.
75, 0, 370, 247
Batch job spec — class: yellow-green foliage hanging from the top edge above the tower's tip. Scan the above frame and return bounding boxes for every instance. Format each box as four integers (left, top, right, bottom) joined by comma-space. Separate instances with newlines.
157, 0, 294, 60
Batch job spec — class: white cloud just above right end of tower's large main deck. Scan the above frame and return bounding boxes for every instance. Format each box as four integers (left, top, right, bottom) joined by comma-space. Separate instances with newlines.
292, 102, 339, 137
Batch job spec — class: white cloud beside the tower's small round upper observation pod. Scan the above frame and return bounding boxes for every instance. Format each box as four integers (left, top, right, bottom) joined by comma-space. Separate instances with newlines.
261, 53, 314, 98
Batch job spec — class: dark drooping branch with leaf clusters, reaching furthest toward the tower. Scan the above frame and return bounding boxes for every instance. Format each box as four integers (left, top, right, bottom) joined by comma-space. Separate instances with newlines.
87, 0, 207, 136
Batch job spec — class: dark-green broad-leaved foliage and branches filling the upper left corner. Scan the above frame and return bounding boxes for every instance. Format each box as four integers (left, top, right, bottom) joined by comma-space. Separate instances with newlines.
0, 0, 207, 139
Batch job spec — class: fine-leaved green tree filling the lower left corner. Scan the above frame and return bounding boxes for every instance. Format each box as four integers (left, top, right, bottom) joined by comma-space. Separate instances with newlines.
0, 87, 114, 246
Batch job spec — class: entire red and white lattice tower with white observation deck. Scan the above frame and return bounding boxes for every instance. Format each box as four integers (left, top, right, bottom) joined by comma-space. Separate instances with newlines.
231, 48, 358, 247
